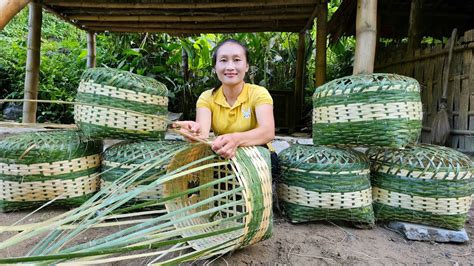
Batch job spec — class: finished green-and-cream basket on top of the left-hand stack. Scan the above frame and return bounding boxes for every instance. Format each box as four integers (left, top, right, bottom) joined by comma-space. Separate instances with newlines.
74, 68, 168, 140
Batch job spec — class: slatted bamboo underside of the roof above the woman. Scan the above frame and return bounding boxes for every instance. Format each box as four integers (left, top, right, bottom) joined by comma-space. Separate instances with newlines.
42, 0, 320, 34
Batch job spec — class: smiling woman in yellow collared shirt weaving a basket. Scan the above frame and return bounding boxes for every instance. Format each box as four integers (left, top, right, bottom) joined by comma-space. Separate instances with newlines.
175, 39, 275, 158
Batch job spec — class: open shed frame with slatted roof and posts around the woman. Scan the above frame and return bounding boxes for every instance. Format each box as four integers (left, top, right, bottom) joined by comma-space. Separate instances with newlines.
0, 0, 334, 133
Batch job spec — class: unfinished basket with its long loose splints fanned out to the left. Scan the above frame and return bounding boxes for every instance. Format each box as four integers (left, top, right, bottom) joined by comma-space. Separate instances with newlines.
0, 142, 272, 264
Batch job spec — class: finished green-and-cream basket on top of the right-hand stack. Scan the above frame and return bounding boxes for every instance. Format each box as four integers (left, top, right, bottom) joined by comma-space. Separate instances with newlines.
313, 74, 422, 148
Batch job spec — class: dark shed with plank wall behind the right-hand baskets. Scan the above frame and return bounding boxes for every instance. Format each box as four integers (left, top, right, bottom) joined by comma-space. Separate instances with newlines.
328, 0, 474, 153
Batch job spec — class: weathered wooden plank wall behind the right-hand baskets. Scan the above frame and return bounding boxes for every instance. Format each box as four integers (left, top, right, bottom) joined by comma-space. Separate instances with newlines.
374, 29, 474, 153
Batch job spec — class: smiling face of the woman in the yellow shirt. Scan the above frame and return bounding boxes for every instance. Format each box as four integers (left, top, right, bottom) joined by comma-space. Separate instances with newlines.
214, 42, 249, 86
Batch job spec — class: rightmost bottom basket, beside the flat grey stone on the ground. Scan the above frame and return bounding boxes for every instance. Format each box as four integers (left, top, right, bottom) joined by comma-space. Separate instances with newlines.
368, 144, 474, 230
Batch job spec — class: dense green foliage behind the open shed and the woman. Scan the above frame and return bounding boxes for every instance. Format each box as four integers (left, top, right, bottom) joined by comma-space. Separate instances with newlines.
0, 5, 354, 123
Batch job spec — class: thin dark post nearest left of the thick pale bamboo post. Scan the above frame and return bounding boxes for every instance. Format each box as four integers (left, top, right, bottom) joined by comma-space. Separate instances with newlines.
316, 0, 328, 87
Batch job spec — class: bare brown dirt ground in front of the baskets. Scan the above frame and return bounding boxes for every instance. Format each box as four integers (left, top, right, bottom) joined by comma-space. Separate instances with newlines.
0, 207, 474, 265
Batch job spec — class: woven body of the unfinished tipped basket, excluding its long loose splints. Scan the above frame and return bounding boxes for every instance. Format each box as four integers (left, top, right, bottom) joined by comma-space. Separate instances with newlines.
164, 144, 272, 255
